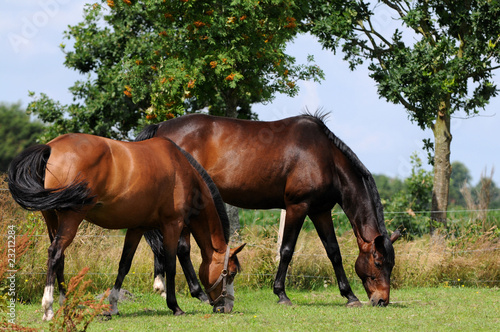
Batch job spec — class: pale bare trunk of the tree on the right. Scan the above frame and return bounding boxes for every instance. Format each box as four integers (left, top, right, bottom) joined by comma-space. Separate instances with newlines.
431, 102, 452, 232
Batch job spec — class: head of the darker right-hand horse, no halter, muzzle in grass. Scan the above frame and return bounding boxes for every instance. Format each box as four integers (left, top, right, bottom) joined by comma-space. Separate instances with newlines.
355, 231, 400, 306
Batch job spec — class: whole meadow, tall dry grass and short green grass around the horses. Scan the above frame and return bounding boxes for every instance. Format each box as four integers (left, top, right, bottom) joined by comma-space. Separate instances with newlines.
0, 175, 500, 331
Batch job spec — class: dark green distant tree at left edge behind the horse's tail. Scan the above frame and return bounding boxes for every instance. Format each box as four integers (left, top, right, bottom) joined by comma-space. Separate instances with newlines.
0, 103, 44, 172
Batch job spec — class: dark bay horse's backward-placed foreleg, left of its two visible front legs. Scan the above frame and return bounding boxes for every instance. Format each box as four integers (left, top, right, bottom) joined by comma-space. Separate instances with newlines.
273, 204, 308, 305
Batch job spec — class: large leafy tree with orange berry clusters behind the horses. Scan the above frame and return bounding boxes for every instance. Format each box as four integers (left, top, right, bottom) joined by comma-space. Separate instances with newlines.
29, 0, 323, 138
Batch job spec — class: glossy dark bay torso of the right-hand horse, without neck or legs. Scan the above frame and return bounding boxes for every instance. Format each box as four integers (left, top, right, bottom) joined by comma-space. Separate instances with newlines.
156, 114, 334, 208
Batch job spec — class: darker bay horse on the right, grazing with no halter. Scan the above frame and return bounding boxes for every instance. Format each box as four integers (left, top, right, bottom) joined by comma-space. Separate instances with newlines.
137, 114, 400, 306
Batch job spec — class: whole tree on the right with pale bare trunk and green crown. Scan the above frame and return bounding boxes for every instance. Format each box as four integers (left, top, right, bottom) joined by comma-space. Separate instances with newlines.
305, 0, 500, 224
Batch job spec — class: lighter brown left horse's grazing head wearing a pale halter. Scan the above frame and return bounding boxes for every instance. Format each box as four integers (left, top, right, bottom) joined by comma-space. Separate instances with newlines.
199, 244, 245, 313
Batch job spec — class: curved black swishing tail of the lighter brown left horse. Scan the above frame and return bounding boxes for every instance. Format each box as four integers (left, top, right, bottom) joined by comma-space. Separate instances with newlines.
8, 145, 94, 211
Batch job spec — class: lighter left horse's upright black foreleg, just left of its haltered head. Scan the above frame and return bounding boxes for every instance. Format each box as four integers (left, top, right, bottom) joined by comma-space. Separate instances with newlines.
163, 222, 184, 316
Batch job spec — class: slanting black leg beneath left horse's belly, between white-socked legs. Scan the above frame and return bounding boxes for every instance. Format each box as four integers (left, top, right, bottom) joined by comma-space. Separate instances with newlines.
108, 229, 144, 315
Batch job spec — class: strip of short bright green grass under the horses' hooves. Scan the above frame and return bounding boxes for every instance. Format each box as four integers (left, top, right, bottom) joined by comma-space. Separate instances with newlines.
12, 287, 500, 331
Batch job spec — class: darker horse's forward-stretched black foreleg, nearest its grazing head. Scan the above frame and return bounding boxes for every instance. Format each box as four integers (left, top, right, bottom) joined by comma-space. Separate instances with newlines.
309, 211, 361, 307
